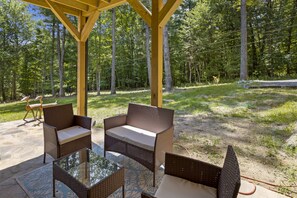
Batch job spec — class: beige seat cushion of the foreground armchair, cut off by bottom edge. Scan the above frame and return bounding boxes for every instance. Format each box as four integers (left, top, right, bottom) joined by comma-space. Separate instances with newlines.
155, 175, 217, 198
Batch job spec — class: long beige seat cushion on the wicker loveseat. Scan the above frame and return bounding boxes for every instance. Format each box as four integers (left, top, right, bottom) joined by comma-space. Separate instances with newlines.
106, 125, 156, 151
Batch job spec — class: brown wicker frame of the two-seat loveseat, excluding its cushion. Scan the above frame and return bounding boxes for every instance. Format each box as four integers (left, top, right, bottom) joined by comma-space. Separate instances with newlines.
104, 103, 174, 186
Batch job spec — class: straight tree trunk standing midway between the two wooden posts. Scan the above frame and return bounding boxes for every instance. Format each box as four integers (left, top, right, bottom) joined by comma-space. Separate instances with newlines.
110, 8, 116, 94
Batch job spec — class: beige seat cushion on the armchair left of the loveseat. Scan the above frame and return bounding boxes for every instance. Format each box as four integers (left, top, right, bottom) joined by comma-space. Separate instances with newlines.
58, 126, 91, 145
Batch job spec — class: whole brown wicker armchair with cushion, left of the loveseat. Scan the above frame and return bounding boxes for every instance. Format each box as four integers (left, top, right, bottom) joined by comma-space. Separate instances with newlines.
43, 104, 92, 163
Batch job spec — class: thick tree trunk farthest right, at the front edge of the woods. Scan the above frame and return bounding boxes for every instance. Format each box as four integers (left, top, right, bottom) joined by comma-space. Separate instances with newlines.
240, 0, 248, 80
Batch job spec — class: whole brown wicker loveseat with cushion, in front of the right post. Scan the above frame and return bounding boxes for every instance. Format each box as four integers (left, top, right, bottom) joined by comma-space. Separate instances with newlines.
104, 103, 174, 186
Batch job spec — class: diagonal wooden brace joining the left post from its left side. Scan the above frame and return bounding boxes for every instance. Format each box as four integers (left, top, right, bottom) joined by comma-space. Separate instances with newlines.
45, 0, 80, 41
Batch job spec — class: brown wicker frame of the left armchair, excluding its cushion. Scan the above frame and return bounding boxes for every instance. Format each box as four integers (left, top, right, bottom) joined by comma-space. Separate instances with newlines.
43, 104, 92, 163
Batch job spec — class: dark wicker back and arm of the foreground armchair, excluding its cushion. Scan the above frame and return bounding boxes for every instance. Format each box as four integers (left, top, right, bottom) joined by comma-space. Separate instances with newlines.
141, 146, 240, 198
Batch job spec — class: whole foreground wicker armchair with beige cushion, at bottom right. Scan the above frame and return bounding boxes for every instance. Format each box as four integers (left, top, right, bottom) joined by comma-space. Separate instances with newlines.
141, 146, 240, 198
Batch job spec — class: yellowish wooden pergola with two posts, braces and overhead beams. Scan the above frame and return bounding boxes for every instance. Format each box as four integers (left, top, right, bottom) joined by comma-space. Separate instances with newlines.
23, 0, 182, 115
